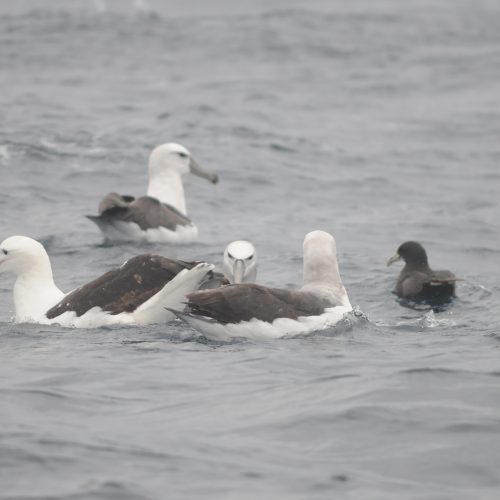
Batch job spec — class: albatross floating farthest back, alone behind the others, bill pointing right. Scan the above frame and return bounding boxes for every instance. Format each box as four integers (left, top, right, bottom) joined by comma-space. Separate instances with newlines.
87, 143, 219, 243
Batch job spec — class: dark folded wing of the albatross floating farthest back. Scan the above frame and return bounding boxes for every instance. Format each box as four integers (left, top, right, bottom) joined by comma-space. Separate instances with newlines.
87, 193, 191, 230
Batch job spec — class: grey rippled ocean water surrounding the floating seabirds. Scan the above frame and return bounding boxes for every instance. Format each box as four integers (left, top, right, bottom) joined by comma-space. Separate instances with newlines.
0, 0, 500, 500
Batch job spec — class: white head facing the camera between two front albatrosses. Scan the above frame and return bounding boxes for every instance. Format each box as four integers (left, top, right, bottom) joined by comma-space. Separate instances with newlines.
222, 240, 257, 283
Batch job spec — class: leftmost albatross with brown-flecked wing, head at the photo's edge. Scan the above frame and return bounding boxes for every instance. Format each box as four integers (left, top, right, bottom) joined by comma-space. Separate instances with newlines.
0, 236, 213, 328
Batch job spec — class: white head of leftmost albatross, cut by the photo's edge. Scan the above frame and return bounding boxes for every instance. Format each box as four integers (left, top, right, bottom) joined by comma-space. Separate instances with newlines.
0, 236, 50, 276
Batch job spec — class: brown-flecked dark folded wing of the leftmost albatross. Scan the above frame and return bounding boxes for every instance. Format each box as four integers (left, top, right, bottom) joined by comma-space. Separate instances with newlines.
46, 254, 201, 319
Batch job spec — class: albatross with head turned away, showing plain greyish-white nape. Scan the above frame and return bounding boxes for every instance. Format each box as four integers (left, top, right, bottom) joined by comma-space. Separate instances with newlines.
177, 231, 352, 340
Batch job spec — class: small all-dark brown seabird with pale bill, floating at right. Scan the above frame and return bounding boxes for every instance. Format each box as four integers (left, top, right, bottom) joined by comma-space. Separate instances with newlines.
387, 241, 458, 303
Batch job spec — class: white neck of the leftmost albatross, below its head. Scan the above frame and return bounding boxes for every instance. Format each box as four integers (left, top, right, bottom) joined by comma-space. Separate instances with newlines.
14, 256, 64, 322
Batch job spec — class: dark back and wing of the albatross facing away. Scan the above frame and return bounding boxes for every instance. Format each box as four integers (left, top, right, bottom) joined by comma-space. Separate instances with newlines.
187, 283, 330, 323
